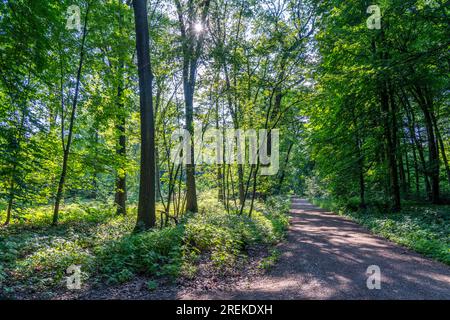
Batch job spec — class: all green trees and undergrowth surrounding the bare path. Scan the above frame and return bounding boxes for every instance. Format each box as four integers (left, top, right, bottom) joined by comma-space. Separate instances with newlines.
0, 0, 450, 296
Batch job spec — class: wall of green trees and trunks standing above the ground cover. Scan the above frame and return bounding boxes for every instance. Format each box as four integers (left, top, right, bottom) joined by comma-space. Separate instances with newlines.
0, 0, 450, 298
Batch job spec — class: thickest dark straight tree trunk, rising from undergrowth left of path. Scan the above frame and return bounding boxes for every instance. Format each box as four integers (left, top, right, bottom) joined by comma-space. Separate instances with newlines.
133, 0, 156, 231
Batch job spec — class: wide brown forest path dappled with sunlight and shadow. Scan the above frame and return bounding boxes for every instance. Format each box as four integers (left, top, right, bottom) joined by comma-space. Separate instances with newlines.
181, 198, 450, 299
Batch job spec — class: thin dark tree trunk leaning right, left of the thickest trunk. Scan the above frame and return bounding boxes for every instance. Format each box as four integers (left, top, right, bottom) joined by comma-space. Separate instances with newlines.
53, 3, 90, 225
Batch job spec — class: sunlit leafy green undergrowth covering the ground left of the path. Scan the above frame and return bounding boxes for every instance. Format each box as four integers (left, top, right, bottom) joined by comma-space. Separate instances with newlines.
0, 193, 289, 298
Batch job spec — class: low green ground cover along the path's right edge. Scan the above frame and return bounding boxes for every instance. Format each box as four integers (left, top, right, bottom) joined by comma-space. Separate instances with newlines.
312, 199, 450, 265
